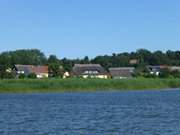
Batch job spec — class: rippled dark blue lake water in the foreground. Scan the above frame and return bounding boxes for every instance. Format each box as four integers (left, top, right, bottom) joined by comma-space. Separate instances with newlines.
0, 90, 180, 135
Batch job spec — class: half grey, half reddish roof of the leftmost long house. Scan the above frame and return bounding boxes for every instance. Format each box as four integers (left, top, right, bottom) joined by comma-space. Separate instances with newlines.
15, 65, 48, 75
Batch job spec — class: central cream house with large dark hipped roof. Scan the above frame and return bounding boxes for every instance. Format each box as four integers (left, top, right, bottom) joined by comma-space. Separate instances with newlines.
72, 64, 108, 79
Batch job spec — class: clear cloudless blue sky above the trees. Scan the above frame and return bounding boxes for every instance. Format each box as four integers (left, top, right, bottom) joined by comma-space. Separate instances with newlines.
0, 0, 180, 58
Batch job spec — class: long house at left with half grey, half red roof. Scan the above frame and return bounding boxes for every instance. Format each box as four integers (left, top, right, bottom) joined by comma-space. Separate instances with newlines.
14, 65, 48, 78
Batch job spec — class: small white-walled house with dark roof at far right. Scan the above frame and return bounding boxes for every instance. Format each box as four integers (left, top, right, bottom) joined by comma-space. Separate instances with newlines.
147, 65, 168, 76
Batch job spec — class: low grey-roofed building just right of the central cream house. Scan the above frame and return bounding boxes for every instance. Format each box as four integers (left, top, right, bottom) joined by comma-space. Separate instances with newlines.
109, 67, 135, 79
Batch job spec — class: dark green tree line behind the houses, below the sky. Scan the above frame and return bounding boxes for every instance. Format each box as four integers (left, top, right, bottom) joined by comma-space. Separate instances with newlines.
0, 49, 180, 78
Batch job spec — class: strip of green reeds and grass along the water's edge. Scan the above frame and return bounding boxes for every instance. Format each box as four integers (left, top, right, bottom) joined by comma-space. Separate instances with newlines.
0, 79, 180, 93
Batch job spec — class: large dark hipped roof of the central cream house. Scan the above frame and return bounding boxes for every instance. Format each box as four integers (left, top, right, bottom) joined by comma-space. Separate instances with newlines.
73, 64, 107, 75
